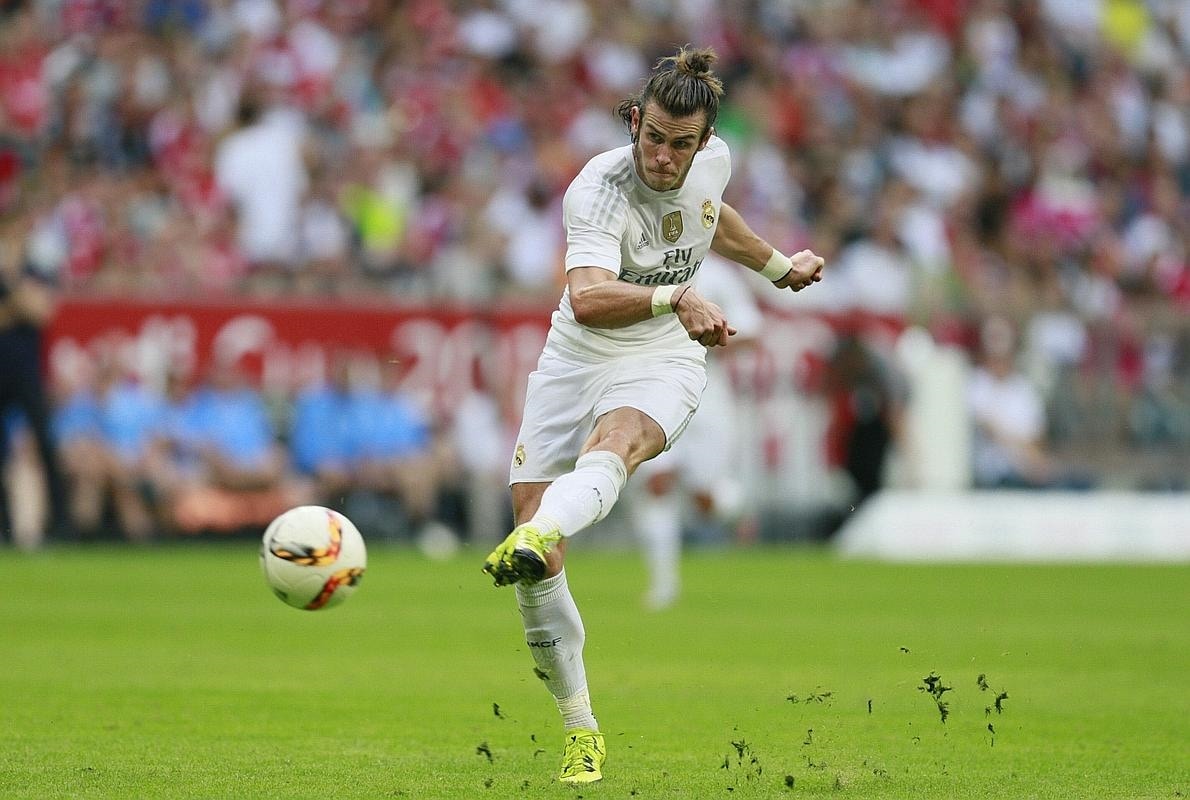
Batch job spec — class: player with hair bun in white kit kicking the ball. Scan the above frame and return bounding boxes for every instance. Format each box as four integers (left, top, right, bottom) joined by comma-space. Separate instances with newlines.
483, 48, 822, 783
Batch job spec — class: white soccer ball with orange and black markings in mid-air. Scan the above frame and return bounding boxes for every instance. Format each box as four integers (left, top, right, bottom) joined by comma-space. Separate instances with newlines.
261, 506, 368, 611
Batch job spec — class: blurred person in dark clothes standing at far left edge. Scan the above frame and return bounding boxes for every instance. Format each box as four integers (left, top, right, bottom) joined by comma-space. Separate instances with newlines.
0, 219, 71, 538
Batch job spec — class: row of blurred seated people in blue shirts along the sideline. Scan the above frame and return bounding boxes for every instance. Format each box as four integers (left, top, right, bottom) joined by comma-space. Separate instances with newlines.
43, 345, 468, 540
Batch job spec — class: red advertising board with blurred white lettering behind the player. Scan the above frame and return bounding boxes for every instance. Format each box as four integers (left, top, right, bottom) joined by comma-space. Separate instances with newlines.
48, 298, 902, 415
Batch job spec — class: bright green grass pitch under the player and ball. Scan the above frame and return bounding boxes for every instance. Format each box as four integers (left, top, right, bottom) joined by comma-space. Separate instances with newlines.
0, 542, 1190, 800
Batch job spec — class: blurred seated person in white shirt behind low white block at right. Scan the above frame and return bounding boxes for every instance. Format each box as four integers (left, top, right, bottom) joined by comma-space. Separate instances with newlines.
967, 317, 1092, 489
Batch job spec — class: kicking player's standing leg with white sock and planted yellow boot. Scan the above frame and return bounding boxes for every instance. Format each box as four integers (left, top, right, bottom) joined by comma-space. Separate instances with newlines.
512, 482, 605, 783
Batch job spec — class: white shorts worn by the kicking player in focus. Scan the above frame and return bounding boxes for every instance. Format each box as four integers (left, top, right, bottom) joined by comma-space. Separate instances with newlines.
508, 349, 707, 485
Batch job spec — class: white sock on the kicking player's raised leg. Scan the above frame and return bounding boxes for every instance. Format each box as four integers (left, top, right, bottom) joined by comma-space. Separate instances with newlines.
530, 450, 628, 536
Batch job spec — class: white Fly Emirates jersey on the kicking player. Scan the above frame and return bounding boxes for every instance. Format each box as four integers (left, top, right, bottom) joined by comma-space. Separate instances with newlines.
547, 136, 732, 358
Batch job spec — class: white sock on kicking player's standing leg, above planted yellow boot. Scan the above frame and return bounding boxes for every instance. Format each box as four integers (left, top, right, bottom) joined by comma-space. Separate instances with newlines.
515, 570, 599, 731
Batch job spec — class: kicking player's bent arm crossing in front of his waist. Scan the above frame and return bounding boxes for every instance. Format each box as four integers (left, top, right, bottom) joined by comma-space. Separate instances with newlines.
566, 267, 735, 346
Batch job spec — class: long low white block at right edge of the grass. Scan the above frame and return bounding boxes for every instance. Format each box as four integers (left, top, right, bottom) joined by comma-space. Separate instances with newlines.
835, 492, 1190, 562
